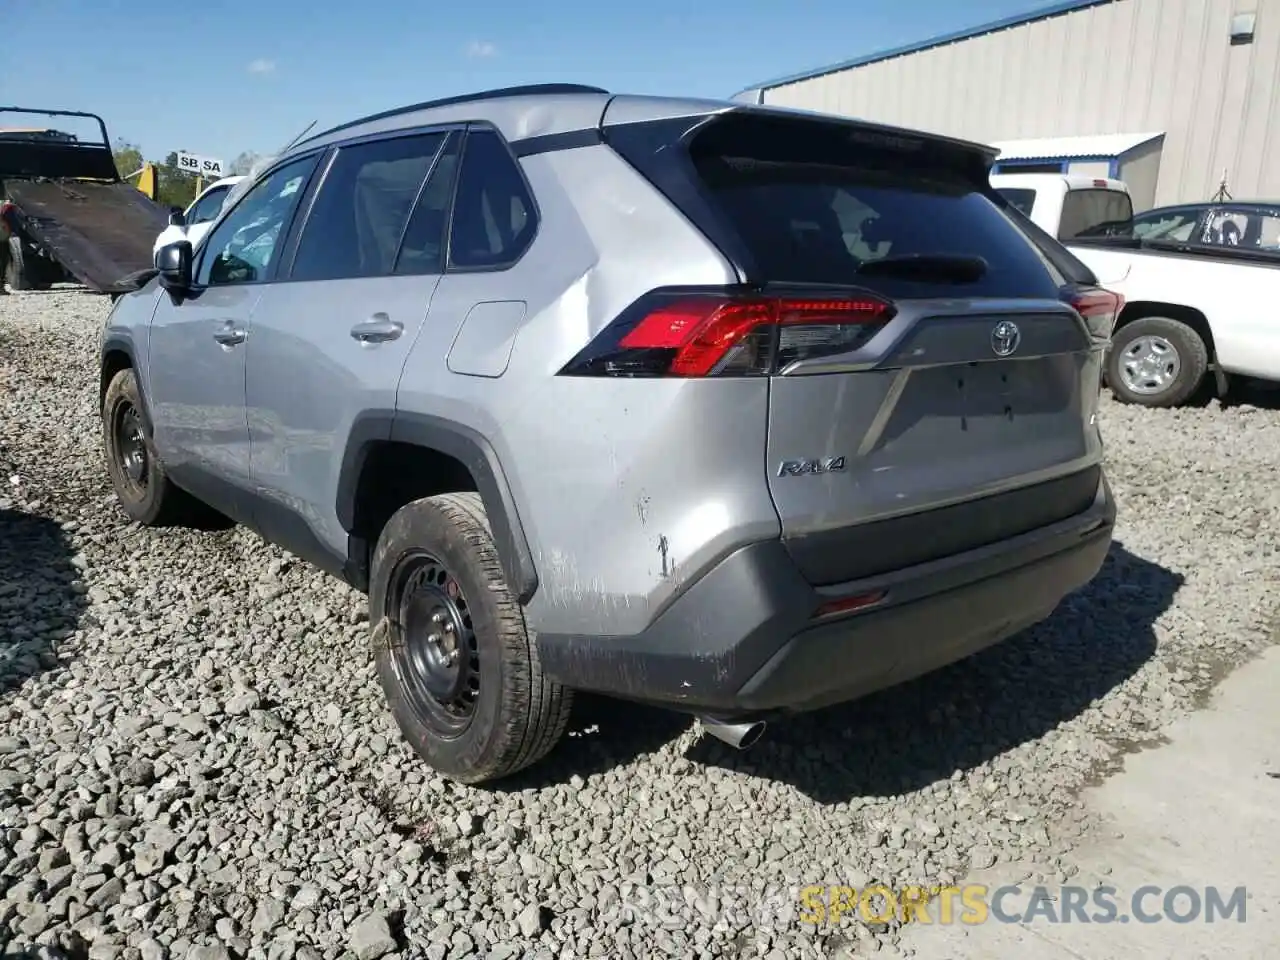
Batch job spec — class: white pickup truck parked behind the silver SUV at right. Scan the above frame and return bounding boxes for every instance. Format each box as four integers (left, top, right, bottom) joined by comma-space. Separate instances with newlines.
991, 174, 1280, 407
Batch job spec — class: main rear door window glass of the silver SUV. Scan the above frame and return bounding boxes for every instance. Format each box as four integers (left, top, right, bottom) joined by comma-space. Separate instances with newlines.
291, 133, 444, 280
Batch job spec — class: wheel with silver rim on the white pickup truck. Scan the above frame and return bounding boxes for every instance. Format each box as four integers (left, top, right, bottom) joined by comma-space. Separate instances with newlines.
1106, 316, 1208, 407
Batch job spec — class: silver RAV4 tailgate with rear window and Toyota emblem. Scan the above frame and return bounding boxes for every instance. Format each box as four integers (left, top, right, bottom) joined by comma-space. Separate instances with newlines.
670, 115, 1110, 582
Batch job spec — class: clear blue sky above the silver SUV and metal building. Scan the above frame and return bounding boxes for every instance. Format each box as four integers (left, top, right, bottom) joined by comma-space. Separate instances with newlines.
0, 0, 1051, 163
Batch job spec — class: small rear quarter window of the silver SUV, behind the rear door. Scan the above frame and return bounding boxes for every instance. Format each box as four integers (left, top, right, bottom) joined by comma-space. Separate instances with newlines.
449, 131, 536, 268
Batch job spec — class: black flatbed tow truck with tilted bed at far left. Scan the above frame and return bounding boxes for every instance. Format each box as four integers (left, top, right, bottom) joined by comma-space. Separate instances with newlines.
0, 106, 169, 297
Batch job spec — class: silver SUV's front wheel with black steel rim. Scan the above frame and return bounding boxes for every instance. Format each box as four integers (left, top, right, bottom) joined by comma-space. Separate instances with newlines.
102, 369, 204, 526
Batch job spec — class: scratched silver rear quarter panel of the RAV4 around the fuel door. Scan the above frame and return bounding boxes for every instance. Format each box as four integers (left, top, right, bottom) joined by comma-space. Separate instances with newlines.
397, 140, 780, 635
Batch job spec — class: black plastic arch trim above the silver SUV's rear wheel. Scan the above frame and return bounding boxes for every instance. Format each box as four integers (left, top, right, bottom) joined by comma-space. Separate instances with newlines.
337, 410, 538, 604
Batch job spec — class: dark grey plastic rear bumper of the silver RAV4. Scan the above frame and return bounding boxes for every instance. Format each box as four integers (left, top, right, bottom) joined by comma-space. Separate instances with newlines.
536, 476, 1116, 719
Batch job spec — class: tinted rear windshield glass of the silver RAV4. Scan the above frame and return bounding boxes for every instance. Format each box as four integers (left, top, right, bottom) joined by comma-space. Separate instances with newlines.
690, 122, 1061, 297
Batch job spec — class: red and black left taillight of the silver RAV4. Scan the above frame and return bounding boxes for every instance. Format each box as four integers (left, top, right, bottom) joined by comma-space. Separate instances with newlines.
561, 291, 893, 376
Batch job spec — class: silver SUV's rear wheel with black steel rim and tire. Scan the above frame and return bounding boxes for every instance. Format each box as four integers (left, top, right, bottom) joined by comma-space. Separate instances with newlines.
369, 493, 572, 785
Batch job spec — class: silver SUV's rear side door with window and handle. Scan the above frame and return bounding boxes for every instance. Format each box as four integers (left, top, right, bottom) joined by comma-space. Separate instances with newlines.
244, 129, 460, 557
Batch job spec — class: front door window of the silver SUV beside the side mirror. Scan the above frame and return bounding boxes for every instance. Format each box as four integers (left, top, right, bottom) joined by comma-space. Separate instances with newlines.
196, 155, 317, 287
